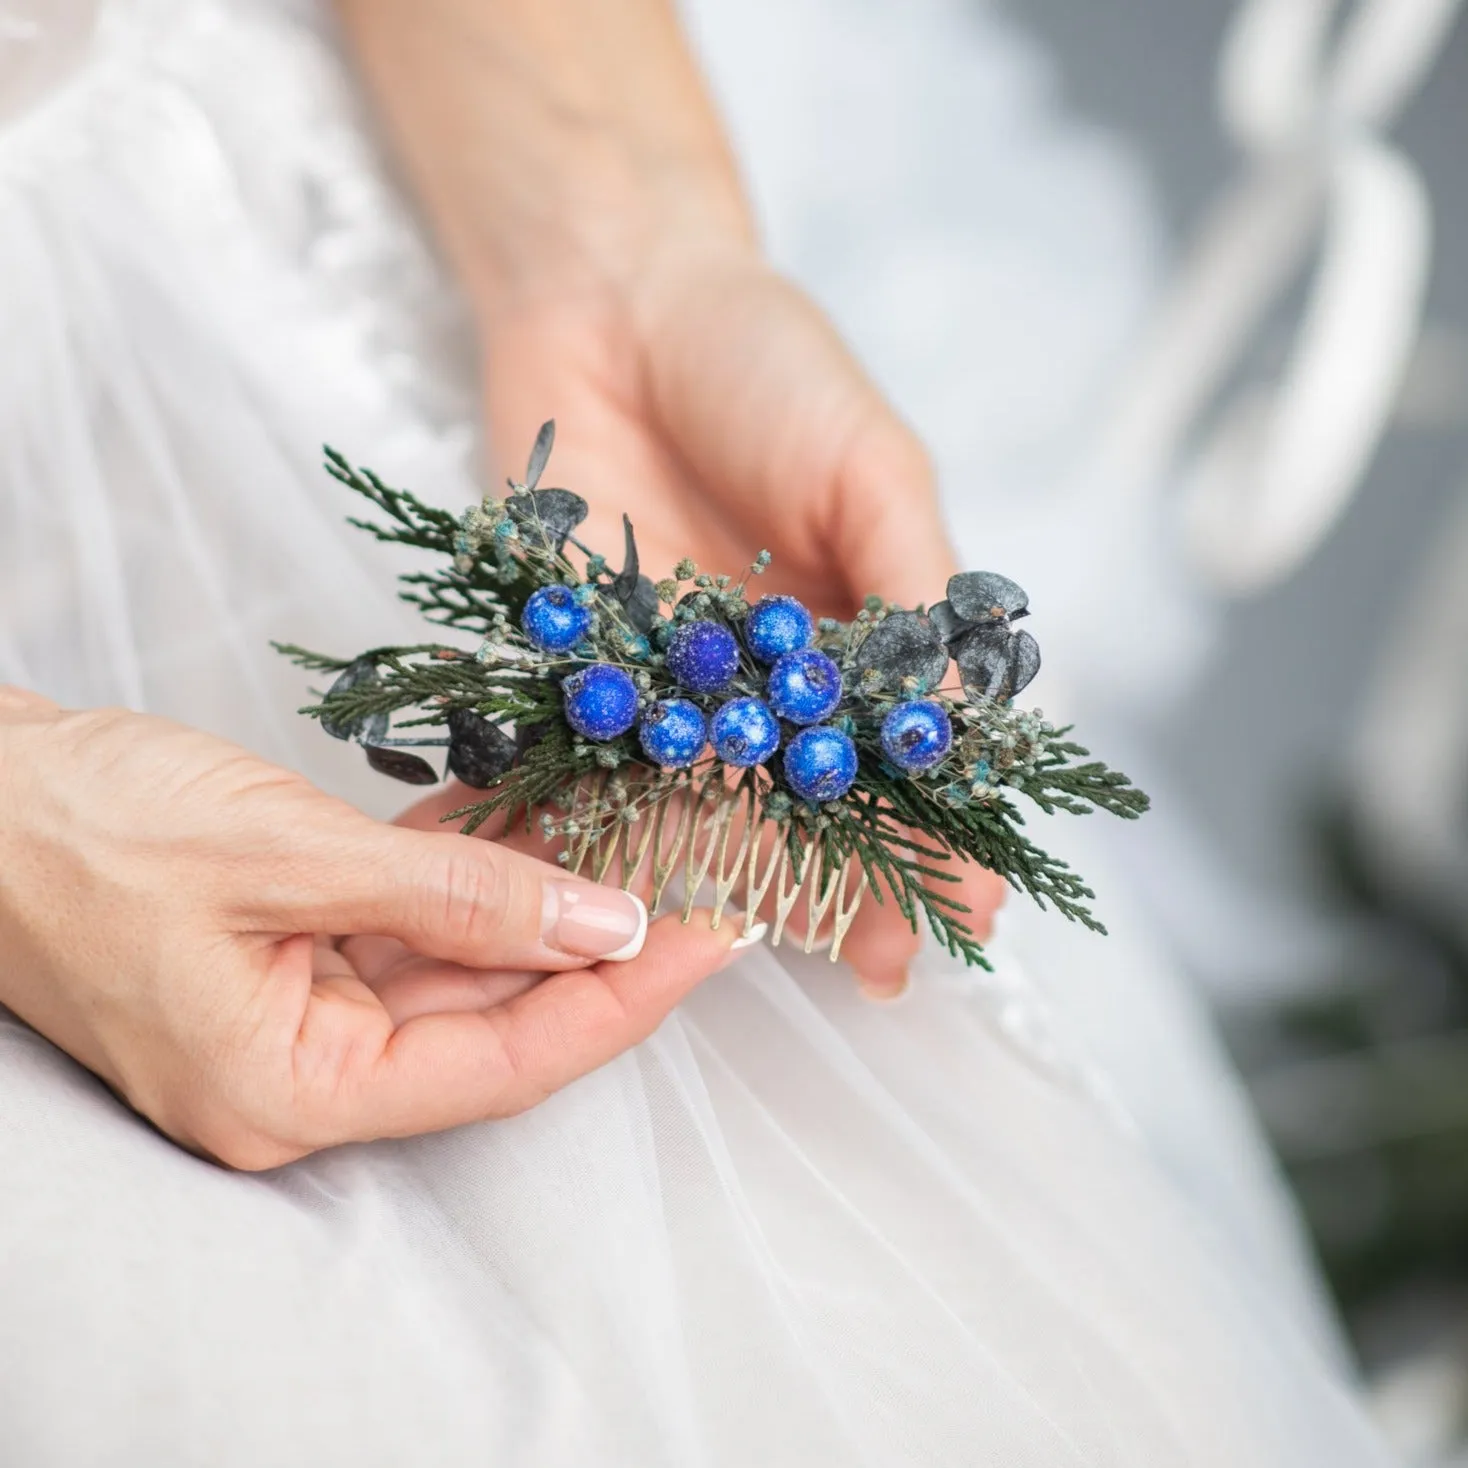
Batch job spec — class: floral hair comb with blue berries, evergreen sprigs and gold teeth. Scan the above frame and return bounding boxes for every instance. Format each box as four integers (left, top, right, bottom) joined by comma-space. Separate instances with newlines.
277, 423, 1148, 964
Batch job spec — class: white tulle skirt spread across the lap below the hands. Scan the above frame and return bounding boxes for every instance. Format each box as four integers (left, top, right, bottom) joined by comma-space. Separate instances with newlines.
0, 953, 1377, 1468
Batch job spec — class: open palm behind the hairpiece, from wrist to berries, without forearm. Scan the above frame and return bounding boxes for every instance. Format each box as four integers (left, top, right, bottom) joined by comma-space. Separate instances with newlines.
484, 258, 956, 617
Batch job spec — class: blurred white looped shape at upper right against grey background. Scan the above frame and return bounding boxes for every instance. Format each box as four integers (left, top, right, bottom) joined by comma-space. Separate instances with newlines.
1102, 0, 1459, 595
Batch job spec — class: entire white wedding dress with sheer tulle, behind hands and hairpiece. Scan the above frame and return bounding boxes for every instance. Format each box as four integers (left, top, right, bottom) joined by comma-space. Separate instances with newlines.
0, 0, 1384, 1468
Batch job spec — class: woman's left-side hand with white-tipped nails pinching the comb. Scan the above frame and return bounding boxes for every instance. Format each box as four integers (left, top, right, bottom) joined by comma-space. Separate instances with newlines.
0, 688, 737, 1169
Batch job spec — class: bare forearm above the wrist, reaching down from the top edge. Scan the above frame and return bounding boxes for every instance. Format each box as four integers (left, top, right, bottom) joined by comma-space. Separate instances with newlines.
339, 0, 753, 317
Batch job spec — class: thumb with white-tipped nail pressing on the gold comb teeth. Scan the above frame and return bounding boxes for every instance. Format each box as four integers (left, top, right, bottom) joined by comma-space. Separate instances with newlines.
255, 821, 647, 970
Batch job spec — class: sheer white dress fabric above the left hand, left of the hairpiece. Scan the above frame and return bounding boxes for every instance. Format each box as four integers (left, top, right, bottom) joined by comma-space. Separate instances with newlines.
0, 0, 473, 809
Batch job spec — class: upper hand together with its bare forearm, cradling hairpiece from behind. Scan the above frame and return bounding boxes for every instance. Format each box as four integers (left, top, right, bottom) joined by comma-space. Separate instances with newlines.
338, 0, 1004, 995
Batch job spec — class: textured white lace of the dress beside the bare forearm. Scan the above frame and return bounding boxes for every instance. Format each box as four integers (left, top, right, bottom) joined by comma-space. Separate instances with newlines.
0, 0, 476, 474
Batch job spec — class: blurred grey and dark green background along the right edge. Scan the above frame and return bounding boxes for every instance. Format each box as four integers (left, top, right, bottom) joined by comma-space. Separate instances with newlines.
1010, 0, 1468, 1462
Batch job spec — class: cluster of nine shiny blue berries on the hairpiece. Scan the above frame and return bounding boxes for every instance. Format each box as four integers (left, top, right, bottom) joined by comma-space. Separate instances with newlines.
521, 586, 953, 804
